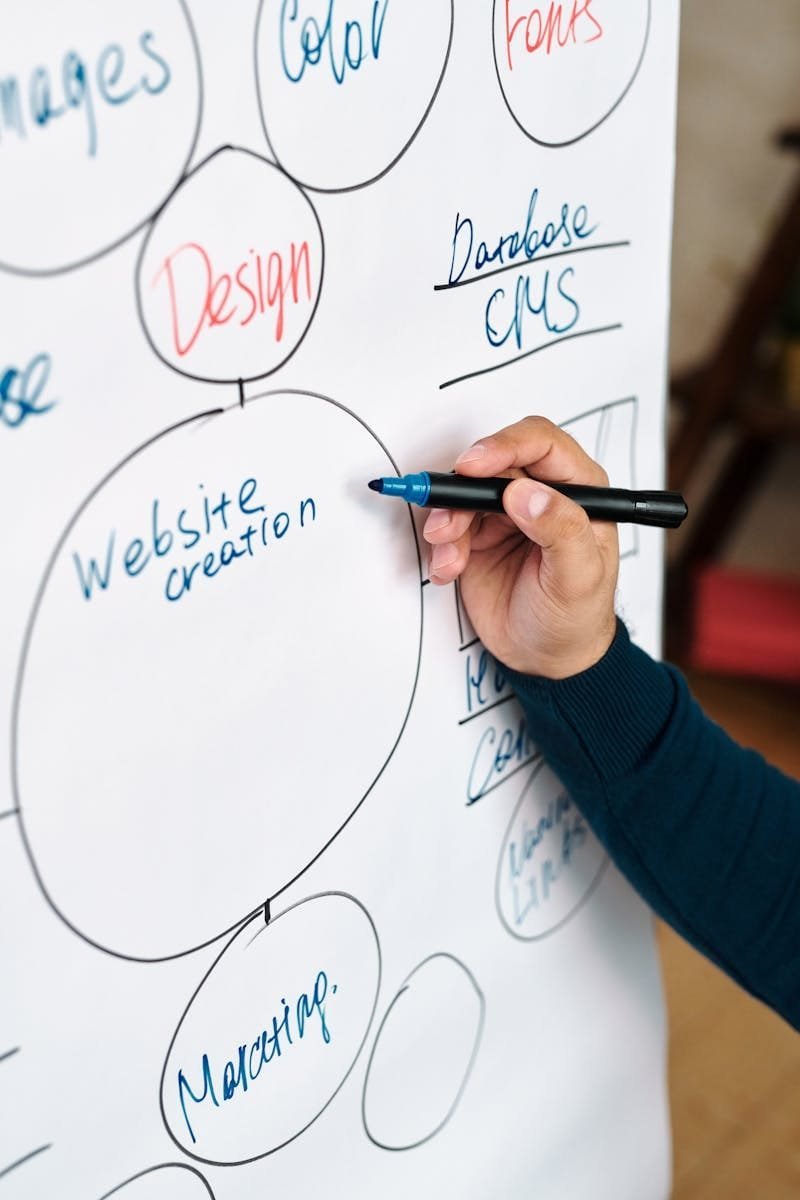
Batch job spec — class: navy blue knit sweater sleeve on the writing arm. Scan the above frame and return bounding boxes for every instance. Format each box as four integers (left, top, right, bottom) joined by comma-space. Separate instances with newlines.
509, 622, 800, 1028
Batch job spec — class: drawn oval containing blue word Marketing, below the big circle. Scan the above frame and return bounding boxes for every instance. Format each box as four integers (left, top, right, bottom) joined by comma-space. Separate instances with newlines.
161, 892, 380, 1166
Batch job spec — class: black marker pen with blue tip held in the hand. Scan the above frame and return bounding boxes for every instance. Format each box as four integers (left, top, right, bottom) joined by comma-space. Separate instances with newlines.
368, 470, 688, 529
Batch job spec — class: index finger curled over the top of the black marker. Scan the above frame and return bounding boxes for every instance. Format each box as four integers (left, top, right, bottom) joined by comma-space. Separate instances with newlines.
456, 416, 608, 487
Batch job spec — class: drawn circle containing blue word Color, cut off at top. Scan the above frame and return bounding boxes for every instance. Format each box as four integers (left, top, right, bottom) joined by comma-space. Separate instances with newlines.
255, 0, 455, 192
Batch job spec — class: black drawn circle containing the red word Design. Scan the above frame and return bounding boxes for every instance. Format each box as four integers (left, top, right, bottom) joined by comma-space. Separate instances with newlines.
137, 146, 325, 383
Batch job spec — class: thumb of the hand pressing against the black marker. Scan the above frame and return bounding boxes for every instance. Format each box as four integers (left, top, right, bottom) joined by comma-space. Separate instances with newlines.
503, 479, 601, 600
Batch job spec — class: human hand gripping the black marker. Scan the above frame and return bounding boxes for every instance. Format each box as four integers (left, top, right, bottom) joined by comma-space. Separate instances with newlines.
422, 416, 619, 679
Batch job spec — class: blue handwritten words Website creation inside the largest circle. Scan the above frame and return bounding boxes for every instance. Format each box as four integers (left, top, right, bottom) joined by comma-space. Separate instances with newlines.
72, 478, 317, 601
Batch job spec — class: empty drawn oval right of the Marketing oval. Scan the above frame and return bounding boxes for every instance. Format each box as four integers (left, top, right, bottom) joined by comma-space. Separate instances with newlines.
361, 954, 486, 1150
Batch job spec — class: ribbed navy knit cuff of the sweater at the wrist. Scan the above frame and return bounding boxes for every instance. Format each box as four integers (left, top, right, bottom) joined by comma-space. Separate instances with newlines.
509, 618, 676, 786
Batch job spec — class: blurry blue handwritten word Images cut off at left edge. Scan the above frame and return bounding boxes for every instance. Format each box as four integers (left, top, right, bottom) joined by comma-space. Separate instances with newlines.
0, 30, 172, 157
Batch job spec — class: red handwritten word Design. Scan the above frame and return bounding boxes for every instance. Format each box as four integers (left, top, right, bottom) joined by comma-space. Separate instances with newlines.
152, 241, 312, 358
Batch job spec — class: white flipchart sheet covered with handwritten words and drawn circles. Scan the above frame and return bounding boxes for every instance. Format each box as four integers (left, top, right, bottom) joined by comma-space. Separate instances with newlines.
0, 0, 678, 1200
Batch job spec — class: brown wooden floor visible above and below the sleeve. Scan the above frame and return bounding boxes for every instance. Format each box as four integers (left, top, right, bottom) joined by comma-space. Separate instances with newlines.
658, 674, 800, 1200
